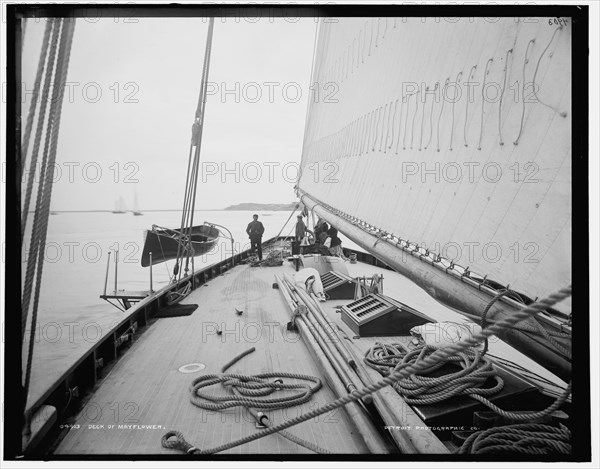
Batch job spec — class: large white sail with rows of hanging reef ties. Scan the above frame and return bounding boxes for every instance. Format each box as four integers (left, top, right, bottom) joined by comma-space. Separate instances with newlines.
298, 18, 571, 312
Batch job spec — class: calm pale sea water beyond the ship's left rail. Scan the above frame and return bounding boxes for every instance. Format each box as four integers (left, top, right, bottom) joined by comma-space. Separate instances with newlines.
22, 211, 314, 403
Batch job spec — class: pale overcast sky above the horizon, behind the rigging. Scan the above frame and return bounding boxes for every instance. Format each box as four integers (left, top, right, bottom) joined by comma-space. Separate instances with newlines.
22, 18, 316, 210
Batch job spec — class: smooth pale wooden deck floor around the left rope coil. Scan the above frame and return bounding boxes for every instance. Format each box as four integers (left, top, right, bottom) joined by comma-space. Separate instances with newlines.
55, 263, 380, 454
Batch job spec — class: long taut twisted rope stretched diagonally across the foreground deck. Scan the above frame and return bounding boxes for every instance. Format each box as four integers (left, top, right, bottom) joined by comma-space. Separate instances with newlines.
161, 285, 572, 454
